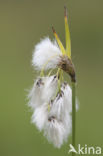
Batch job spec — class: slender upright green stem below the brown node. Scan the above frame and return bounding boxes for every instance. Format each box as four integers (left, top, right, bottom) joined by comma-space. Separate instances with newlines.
72, 82, 76, 156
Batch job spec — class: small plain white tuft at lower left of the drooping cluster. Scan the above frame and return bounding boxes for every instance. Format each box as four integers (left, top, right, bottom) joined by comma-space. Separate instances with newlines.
32, 103, 48, 131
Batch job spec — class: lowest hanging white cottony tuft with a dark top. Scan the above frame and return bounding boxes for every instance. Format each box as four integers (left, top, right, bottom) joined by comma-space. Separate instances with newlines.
44, 114, 72, 148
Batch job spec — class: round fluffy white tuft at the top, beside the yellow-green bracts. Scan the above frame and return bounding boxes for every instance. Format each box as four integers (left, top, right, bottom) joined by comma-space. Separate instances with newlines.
32, 38, 62, 70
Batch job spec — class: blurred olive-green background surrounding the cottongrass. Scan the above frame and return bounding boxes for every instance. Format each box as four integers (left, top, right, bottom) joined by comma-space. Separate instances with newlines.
0, 0, 103, 156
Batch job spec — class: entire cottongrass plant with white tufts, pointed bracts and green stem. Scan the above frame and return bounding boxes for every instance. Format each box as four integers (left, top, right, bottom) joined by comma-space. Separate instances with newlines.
28, 8, 77, 152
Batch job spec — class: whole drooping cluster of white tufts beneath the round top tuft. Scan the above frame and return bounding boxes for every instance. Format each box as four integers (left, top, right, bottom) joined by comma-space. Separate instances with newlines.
29, 75, 77, 148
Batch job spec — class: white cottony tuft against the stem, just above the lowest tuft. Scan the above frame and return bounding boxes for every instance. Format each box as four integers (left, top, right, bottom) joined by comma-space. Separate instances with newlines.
50, 83, 72, 120
